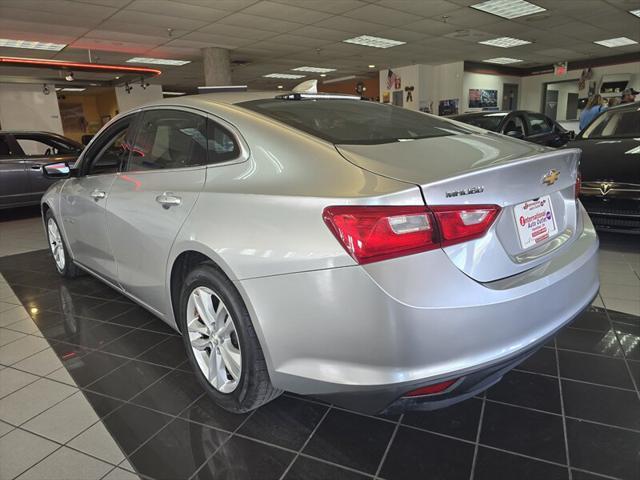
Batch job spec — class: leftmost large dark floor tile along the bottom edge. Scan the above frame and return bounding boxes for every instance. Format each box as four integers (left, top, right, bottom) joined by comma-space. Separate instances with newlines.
129, 418, 228, 479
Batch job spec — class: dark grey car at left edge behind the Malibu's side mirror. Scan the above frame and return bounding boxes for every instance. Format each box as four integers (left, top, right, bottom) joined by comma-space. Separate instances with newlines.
0, 131, 83, 209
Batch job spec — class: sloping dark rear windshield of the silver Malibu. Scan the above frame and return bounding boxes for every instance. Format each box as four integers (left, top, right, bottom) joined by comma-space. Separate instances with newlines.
238, 99, 469, 145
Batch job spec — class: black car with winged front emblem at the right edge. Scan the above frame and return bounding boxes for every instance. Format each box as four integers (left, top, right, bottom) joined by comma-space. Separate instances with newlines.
567, 103, 640, 233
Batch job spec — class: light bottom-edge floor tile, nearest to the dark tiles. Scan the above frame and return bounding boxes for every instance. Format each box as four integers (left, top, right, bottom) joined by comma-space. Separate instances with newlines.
18, 447, 112, 480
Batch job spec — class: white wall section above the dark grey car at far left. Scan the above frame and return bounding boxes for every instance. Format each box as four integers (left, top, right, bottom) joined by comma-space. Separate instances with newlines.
0, 83, 62, 134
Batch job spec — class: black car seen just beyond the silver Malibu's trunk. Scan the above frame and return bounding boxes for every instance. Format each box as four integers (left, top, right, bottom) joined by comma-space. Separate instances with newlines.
450, 110, 574, 148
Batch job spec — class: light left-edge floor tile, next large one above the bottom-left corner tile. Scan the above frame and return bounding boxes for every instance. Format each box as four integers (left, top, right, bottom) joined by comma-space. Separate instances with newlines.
0, 378, 78, 425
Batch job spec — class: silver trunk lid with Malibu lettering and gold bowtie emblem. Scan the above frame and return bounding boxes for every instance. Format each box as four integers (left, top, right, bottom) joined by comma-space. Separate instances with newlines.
336, 133, 582, 282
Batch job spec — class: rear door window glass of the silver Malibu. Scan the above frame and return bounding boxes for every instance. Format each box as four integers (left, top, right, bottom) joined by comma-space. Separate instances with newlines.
127, 109, 207, 171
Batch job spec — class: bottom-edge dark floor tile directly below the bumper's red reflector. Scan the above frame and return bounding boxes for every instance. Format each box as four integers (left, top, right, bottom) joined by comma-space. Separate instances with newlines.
380, 427, 475, 480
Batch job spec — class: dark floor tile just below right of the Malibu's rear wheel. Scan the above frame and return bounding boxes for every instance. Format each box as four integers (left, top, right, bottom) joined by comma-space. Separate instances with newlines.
238, 397, 328, 450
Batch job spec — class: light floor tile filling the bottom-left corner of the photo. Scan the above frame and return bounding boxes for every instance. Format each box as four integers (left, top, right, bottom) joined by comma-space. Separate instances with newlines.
0, 429, 59, 479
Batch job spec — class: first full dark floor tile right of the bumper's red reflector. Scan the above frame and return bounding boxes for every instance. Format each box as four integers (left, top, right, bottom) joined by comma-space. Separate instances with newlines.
487, 372, 561, 413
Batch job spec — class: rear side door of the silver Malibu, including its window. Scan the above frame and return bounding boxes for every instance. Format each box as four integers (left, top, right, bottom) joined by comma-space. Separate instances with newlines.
107, 108, 207, 316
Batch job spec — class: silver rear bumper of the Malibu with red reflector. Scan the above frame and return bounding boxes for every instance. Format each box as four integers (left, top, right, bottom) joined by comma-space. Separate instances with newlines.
238, 211, 599, 413
